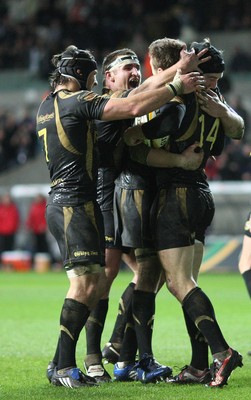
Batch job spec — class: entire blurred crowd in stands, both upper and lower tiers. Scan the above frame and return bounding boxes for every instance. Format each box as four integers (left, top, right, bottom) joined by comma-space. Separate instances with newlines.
0, 0, 251, 180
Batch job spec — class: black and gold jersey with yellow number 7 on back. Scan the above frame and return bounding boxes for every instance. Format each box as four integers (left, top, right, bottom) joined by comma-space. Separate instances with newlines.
37, 90, 109, 205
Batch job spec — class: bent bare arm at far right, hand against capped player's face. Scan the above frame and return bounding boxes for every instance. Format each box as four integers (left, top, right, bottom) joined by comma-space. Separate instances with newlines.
197, 90, 245, 140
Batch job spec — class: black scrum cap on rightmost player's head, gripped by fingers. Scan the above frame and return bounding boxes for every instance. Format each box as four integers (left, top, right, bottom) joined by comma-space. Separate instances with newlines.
191, 41, 225, 74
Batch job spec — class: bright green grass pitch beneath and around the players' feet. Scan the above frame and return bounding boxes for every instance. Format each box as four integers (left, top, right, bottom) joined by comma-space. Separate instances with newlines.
0, 272, 251, 400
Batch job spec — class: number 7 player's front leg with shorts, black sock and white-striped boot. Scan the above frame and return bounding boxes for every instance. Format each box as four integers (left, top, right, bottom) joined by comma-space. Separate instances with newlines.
47, 202, 105, 387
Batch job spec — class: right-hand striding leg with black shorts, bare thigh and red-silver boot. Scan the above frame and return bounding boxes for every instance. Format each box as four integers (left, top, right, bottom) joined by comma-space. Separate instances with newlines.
156, 188, 242, 387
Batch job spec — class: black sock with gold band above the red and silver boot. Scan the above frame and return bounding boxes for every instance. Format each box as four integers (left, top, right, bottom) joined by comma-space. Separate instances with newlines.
183, 287, 229, 354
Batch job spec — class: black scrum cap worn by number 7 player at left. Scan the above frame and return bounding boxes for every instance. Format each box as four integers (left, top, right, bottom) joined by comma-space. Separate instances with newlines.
57, 48, 97, 90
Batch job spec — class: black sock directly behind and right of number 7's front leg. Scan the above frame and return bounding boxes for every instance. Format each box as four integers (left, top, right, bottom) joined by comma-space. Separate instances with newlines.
85, 299, 109, 366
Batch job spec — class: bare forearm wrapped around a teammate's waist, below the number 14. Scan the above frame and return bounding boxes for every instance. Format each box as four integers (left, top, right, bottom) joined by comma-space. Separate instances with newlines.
129, 143, 203, 170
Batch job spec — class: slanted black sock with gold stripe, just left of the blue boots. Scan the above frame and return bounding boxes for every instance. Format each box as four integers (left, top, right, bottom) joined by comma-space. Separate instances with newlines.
109, 282, 135, 344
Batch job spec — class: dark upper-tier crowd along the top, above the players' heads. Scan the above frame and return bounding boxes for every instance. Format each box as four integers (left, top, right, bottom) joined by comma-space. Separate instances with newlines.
0, 0, 251, 71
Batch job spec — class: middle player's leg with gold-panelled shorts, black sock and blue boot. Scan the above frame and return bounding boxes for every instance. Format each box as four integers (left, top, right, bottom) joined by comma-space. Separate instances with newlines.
114, 189, 172, 382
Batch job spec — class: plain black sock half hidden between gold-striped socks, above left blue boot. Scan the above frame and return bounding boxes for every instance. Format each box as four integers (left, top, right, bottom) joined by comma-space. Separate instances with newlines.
119, 305, 137, 362
